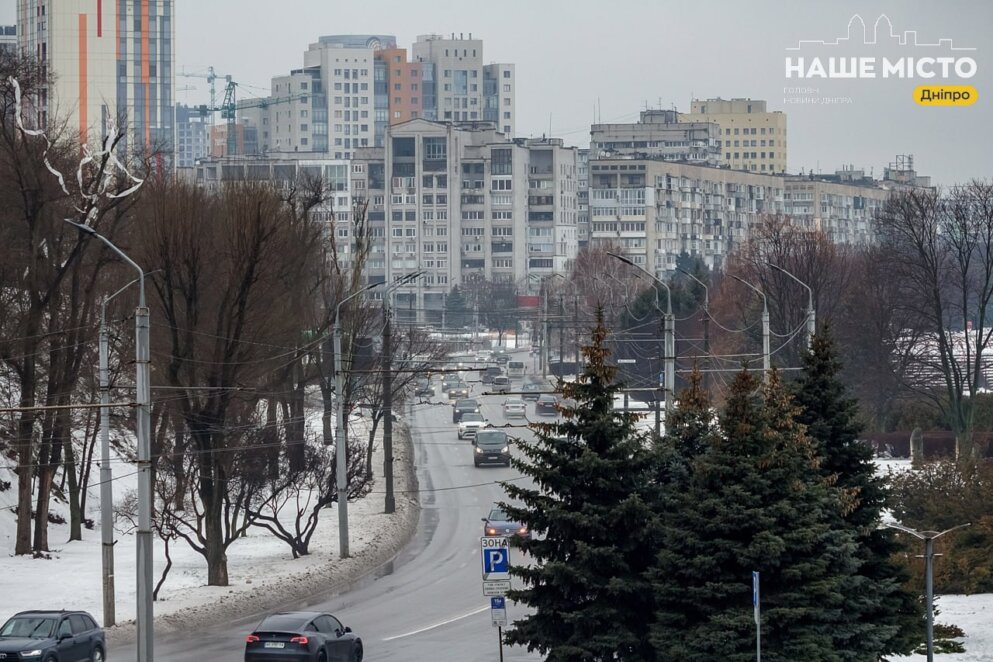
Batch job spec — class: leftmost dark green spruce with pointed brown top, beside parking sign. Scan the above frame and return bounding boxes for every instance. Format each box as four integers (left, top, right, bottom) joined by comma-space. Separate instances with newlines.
504, 311, 655, 662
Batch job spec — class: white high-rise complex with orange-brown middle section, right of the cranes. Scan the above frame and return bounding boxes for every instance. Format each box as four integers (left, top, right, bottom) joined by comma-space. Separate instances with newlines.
238, 35, 515, 159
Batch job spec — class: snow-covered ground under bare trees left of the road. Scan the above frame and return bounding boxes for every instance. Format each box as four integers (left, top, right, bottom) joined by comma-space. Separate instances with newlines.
0, 404, 418, 639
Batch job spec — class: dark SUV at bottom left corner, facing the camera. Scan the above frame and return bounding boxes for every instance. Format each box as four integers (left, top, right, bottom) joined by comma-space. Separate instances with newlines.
0, 611, 107, 662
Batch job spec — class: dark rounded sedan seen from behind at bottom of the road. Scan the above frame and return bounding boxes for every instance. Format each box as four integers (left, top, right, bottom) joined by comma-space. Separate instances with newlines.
245, 611, 363, 662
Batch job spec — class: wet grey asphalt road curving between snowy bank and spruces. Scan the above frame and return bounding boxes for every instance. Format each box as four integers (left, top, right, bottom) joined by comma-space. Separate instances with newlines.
122, 368, 541, 662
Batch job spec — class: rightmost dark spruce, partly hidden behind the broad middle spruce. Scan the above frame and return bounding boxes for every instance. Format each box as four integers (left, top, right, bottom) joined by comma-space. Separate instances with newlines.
792, 327, 923, 659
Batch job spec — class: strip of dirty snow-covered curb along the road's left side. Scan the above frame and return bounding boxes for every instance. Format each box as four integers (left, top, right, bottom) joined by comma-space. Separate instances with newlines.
106, 422, 421, 647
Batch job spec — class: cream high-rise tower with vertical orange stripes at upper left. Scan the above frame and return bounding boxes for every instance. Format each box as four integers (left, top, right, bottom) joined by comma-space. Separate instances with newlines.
17, 0, 175, 153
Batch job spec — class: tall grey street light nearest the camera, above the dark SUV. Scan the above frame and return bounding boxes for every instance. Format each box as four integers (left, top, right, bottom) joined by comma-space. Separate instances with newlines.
65, 219, 153, 662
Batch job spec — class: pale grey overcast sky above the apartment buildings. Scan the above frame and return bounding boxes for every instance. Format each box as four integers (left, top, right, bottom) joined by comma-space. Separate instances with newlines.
5, 0, 993, 184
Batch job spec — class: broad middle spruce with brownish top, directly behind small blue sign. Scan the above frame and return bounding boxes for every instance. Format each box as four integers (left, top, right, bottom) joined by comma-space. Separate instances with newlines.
649, 371, 857, 661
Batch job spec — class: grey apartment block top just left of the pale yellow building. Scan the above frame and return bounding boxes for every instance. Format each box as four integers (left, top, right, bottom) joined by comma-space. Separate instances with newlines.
590, 110, 721, 166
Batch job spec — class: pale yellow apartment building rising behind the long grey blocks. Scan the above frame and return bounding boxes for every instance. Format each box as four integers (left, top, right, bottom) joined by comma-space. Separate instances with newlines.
680, 97, 788, 174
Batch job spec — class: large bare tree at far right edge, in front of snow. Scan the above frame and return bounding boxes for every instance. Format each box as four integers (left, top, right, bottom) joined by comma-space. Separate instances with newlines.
877, 181, 993, 461
